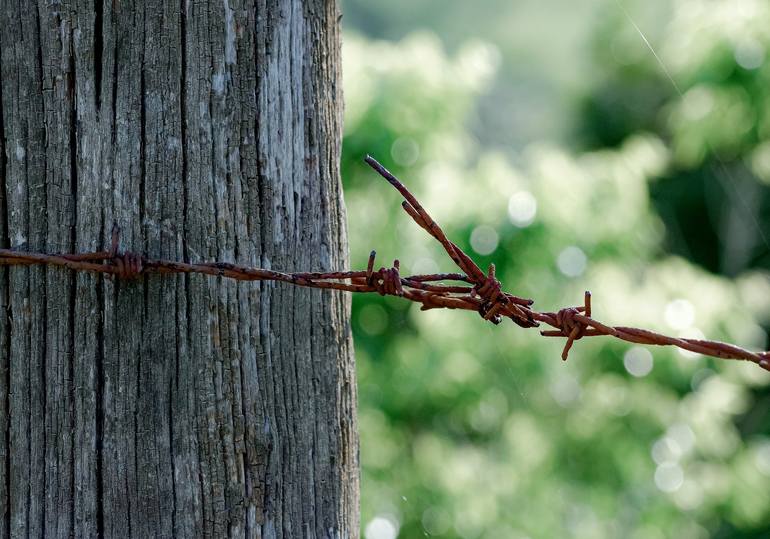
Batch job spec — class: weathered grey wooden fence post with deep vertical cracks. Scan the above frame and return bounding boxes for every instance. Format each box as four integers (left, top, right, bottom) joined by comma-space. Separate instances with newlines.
0, 0, 358, 538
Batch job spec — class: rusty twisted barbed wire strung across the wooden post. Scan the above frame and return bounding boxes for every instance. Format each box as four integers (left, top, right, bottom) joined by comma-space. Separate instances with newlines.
0, 156, 770, 371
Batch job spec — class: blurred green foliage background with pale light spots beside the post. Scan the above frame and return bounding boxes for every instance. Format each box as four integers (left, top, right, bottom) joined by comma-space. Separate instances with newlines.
342, 0, 770, 539
